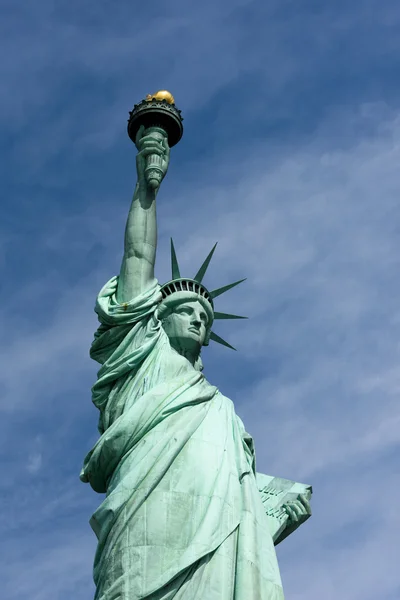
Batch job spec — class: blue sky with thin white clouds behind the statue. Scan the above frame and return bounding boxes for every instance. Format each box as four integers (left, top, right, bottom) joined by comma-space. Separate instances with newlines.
0, 0, 400, 600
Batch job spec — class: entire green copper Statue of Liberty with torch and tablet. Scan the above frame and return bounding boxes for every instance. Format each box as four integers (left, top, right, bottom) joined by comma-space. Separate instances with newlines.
81, 92, 311, 600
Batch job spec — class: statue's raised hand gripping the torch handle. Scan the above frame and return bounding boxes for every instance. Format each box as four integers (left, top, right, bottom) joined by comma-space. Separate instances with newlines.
135, 125, 170, 191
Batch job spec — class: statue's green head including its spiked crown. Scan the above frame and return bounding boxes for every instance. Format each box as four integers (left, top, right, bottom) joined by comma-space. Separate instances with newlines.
158, 240, 245, 359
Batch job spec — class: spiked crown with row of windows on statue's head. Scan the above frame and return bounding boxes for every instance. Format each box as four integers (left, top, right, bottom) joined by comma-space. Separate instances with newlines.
160, 238, 247, 350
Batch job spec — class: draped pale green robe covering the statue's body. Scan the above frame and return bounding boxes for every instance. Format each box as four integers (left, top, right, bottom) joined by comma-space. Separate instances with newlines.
81, 278, 283, 600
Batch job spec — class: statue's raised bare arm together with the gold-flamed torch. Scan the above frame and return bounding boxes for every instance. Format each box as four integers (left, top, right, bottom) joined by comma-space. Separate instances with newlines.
117, 91, 182, 303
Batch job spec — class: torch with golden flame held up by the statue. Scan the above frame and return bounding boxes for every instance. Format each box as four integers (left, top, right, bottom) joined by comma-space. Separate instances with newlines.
128, 90, 183, 190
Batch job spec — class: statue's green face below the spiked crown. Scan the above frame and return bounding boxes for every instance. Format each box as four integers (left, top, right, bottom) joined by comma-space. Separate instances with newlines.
163, 300, 208, 354
